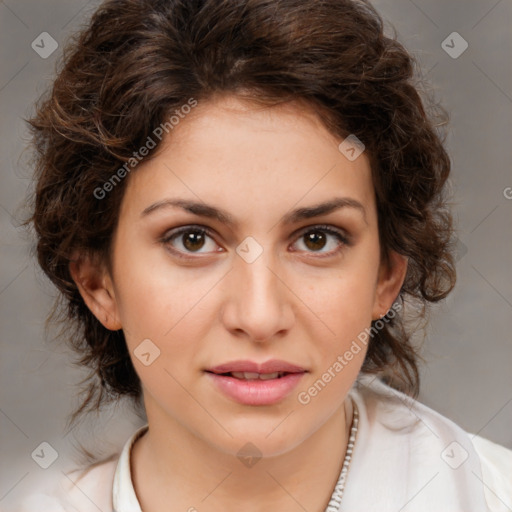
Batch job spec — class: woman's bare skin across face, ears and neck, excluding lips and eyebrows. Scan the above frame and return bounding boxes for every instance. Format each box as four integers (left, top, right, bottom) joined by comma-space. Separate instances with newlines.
71, 96, 407, 512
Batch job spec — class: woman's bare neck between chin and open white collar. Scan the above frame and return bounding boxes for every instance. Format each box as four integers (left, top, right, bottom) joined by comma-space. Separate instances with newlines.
131, 398, 352, 512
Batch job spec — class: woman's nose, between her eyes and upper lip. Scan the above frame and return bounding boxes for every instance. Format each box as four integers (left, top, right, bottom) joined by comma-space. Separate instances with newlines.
222, 251, 294, 342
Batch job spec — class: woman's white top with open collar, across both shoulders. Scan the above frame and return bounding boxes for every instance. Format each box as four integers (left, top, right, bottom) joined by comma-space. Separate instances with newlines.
19, 376, 512, 512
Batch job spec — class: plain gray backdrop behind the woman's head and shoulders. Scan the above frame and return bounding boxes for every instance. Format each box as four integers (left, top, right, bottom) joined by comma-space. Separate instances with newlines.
0, 0, 512, 510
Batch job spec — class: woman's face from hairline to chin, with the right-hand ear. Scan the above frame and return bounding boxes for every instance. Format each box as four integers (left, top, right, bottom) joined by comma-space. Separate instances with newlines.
82, 97, 405, 455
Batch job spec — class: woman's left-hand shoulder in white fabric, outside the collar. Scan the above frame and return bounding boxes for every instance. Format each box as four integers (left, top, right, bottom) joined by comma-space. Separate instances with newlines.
16, 455, 118, 512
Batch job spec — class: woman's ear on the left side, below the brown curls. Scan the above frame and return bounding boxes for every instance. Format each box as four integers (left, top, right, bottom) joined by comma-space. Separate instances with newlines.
69, 254, 122, 331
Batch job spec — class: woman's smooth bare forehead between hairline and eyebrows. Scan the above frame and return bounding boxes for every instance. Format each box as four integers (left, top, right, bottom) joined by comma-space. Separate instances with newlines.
120, 97, 374, 226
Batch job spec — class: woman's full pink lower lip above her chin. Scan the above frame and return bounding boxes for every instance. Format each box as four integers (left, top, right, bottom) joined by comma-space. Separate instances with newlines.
206, 372, 304, 405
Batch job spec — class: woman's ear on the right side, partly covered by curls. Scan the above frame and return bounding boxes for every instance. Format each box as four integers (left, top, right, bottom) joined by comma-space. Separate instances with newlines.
372, 251, 407, 320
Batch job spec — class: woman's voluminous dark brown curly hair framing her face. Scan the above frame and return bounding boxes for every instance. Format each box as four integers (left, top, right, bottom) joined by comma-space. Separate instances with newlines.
27, 0, 455, 432
